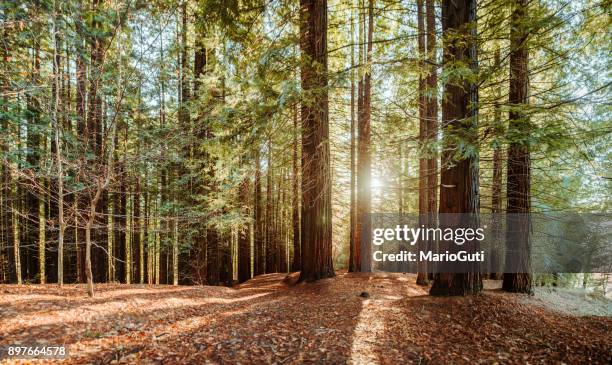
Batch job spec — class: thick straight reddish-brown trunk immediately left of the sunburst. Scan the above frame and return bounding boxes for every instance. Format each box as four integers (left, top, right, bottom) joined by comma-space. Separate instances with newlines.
300, 0, 334, 281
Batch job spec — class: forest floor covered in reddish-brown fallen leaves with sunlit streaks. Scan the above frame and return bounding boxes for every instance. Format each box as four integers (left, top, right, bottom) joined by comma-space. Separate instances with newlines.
0, 273, 612, 364
